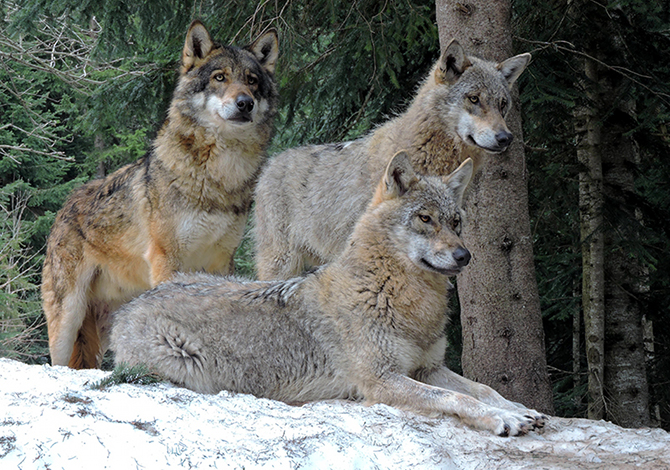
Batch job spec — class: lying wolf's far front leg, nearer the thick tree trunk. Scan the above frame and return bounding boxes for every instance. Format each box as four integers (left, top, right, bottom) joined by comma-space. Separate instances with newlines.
416, 366, 547, 428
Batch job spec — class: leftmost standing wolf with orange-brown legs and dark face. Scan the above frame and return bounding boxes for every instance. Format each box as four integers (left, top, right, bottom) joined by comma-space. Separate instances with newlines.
42, 21, 278, 368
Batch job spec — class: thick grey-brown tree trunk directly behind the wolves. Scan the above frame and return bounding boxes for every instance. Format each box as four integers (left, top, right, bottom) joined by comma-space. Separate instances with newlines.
436, 0, 553, 413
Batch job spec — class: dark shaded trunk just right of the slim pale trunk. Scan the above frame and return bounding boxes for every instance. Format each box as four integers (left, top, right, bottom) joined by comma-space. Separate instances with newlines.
602, 103, 650, 427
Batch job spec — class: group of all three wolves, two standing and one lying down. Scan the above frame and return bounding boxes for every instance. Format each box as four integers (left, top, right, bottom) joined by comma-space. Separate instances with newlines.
42, 20, 546, 436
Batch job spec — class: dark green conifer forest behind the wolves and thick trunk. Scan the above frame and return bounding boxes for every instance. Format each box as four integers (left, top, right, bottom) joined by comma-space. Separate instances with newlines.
0, 0, 670, 429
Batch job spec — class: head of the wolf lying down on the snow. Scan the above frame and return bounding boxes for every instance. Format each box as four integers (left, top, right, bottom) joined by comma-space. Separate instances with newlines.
368, 151, 474, 275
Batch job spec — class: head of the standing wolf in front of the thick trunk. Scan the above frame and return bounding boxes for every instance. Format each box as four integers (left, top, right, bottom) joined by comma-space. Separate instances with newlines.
433, 39, 531, 153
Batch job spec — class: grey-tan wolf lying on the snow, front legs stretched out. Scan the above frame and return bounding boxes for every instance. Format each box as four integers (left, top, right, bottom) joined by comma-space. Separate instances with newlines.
111, 152, 545, 436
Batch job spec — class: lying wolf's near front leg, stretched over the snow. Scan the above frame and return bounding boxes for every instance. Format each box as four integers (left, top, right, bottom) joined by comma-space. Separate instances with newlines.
365, 373, 534, 436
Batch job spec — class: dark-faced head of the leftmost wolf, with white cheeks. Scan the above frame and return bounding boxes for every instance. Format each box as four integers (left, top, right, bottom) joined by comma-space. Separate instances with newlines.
173, 20, 279, 132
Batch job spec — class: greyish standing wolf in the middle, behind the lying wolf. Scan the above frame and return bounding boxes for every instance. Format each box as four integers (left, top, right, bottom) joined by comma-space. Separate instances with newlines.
255, 41, 530, 280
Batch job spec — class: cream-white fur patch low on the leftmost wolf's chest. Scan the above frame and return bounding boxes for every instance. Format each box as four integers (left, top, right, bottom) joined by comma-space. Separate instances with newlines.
176, 207, 246, 271
